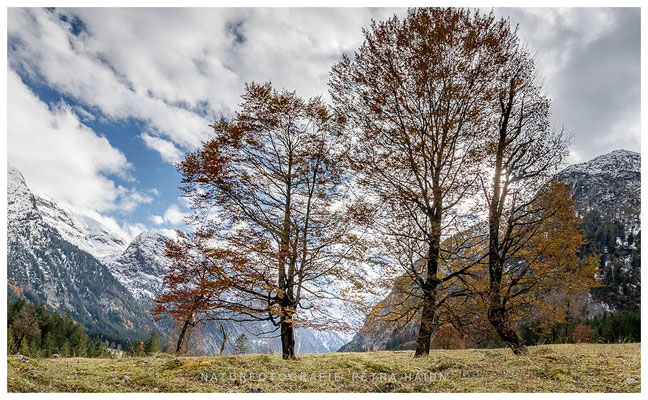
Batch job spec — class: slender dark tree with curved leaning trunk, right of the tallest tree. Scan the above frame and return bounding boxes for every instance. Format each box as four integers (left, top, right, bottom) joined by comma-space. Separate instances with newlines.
480, 29, 591, 354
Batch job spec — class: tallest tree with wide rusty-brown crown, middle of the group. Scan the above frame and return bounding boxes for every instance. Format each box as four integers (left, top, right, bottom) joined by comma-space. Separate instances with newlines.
329, 8, 507, 356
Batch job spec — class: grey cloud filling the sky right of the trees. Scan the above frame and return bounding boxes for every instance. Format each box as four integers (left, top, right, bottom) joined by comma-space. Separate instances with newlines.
496, 8, 641, 161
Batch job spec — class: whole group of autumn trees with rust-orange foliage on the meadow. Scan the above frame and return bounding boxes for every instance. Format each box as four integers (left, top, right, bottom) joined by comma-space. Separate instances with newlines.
154, 8, 598, 359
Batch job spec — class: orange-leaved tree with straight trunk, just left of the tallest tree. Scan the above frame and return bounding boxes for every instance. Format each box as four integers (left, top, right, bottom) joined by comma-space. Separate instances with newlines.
178, 83, 367, 359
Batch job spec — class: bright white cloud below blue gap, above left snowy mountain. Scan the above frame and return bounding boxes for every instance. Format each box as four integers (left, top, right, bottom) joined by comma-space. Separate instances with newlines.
7, 70, 152, 212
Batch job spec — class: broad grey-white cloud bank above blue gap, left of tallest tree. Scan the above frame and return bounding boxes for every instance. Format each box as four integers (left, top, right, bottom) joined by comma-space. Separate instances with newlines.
8, 8, 403, 162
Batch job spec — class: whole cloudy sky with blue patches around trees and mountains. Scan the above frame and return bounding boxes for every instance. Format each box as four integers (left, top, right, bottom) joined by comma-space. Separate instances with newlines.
7, 8, 640, 239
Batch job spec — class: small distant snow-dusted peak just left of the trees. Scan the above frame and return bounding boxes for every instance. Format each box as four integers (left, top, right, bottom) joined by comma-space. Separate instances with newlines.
105, 232, 169, 303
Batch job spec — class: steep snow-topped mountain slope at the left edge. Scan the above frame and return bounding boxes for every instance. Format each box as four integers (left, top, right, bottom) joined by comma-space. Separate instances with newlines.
7, 167, 151, 340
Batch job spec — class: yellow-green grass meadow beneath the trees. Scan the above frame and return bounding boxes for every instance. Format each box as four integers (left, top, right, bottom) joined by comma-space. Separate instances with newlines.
7, 343, 641, 392
